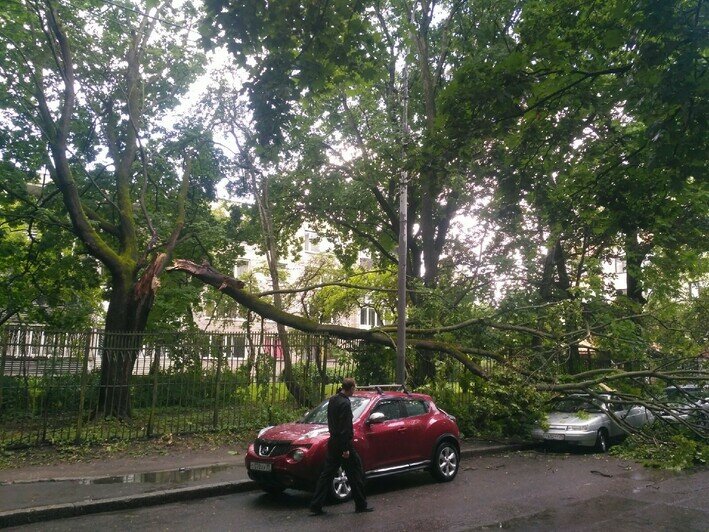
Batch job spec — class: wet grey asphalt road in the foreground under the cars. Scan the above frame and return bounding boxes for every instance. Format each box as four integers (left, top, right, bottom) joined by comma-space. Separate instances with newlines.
6, 451, 709, 532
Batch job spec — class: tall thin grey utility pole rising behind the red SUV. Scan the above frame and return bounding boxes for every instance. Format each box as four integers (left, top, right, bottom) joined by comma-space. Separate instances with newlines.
396, 4, 414, 386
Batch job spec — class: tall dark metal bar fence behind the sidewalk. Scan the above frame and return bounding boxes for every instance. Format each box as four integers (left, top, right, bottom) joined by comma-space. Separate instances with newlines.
0, 327, 404, 446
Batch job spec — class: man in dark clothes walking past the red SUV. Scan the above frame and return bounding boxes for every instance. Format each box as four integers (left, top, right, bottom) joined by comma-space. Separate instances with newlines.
310, 377, 372, 515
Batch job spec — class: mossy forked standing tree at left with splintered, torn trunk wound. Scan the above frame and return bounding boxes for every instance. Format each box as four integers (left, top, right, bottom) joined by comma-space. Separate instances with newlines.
0, 0, 201, 418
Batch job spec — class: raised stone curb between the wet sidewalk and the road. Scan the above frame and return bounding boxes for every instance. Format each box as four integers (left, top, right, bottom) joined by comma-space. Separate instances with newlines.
0, 443, 536, 528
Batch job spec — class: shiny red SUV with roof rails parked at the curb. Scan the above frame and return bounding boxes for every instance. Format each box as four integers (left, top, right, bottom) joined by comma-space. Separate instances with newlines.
246, 386, 460, 501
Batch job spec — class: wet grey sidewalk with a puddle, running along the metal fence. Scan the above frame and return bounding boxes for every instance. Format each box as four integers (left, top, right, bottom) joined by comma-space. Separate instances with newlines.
0, 440, 530, 528
